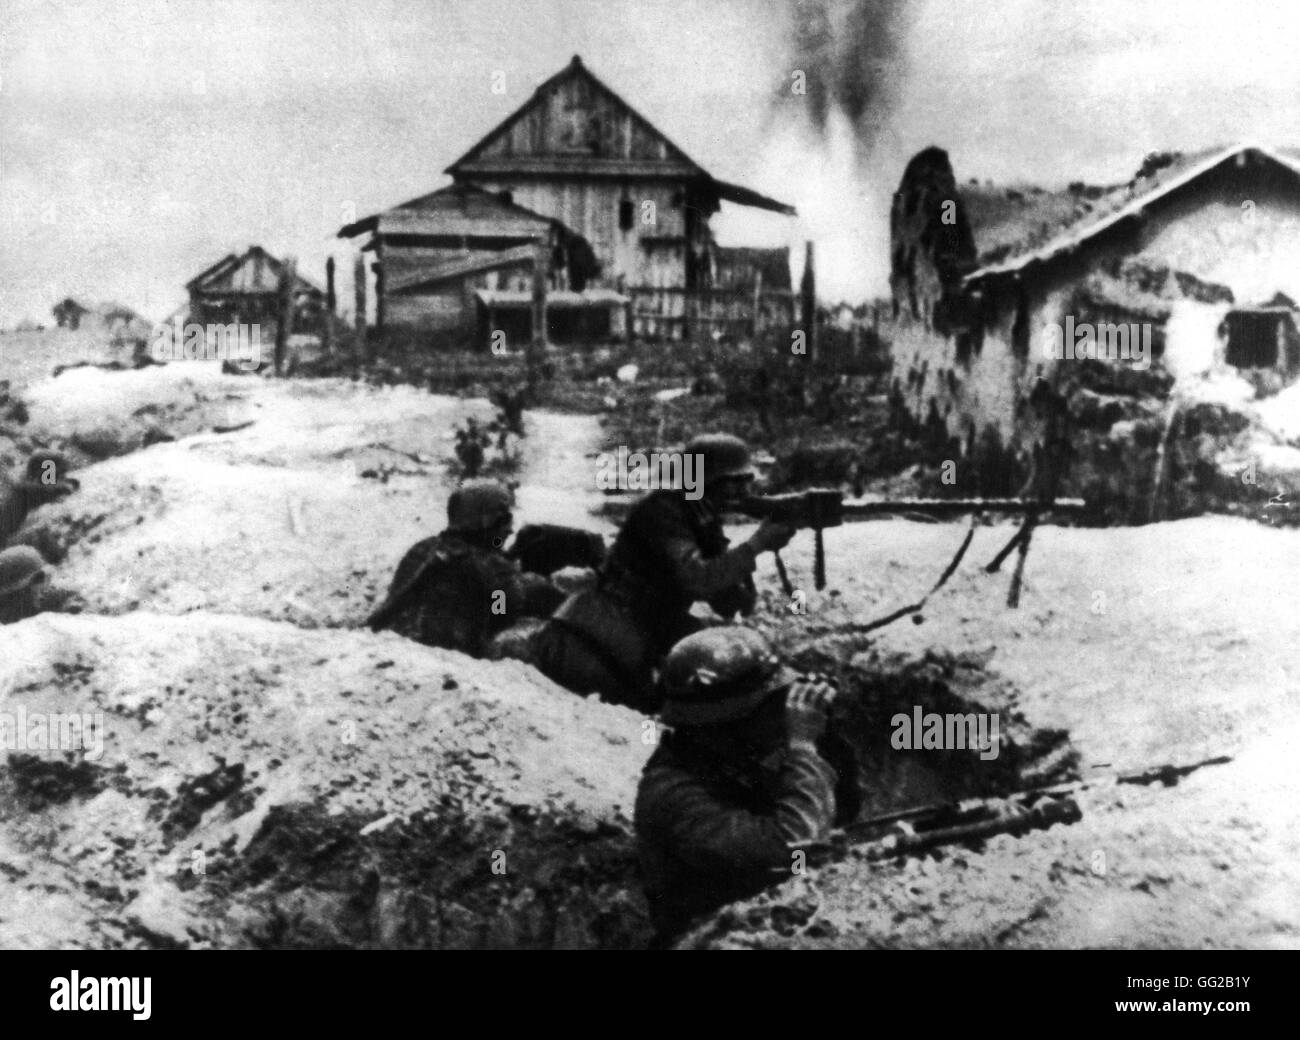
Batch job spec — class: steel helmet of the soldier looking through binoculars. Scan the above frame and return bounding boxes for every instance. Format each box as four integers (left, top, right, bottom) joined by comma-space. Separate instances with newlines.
659, 625, 796, 725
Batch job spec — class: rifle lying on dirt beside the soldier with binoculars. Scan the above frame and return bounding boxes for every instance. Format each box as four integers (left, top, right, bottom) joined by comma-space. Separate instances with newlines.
783, 755, 1232, 871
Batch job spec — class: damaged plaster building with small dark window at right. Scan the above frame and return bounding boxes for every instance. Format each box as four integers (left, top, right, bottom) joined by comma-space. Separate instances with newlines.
881, 146, 1300, 521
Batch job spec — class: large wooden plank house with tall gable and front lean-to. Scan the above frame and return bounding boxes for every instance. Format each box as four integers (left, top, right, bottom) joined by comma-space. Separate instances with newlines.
339, 56, 794, 347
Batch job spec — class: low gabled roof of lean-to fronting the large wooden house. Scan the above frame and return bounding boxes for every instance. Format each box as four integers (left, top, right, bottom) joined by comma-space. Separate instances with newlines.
338, 183, 558, 238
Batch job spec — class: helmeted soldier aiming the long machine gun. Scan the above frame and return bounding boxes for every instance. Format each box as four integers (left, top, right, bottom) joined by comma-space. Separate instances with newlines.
533, 434, 794, 711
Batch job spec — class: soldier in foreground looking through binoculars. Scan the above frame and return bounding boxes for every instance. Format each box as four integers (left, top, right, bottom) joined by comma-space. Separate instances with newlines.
636, 627, 837, 945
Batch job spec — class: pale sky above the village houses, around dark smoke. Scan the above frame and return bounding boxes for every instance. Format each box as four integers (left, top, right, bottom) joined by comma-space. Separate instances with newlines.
0, 0, 1300, 325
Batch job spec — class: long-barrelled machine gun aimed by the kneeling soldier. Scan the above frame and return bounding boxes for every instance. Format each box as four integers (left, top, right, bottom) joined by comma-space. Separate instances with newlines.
740, 489, 1086, 590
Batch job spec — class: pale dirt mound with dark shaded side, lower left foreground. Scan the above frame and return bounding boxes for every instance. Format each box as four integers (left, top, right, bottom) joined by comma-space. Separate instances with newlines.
0, 612, 650, 948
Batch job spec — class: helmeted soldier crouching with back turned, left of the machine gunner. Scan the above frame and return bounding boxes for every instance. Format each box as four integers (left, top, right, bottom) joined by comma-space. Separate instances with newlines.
367, 480, 563, 657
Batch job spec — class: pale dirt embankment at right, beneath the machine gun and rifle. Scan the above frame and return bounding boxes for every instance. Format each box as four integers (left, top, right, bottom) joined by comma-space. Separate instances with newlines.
688, 517, 1300, 949
